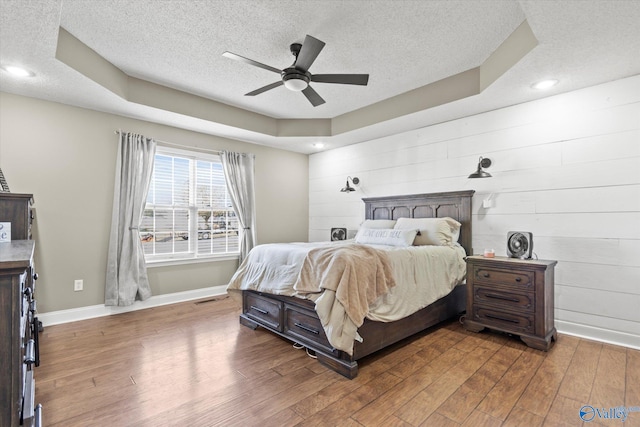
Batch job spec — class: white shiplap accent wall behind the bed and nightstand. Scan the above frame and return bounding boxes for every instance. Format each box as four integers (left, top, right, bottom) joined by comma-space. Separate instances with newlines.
309, 76, 640, 348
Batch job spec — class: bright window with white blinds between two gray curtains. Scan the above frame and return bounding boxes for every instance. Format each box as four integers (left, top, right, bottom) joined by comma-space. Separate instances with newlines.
140, 147, 240, 262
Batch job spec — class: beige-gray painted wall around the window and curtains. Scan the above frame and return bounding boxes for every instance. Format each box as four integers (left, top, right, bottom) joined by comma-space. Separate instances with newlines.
0, 92, 309, 313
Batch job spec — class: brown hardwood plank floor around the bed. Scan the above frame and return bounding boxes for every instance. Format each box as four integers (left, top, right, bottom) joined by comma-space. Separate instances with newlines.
36, 297, 640, 427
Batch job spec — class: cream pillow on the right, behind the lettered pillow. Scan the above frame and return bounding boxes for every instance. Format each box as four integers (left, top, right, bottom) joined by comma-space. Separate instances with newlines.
394, 217, 461, 246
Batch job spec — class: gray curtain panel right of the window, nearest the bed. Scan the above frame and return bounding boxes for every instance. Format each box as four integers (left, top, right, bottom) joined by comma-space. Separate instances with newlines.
220, 151, 256, 263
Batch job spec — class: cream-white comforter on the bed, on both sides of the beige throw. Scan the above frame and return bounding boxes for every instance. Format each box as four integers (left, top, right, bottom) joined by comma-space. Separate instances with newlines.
227, 240, 466, 352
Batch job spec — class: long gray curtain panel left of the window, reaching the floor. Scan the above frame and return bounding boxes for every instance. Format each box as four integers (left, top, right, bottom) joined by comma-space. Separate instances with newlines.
104, 132, 156, 306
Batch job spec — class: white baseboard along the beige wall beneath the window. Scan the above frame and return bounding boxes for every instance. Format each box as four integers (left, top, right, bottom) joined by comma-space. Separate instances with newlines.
38, 285, 227, 326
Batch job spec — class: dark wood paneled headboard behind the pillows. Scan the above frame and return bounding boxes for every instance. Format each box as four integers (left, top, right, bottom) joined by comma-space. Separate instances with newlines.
362, 190, 475, 255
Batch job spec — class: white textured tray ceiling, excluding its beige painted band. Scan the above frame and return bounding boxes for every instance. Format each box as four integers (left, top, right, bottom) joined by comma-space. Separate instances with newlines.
0, 0, 640, 153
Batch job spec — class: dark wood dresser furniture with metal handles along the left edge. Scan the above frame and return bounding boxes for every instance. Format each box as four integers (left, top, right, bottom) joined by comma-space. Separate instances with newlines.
0, 193, 42, 427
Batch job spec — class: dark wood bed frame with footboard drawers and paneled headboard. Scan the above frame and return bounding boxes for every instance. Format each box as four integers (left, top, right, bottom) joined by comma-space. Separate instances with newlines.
228, 190, 474, 378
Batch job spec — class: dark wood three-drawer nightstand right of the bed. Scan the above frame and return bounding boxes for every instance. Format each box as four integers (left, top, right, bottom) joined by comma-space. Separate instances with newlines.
464, 256, 557, 351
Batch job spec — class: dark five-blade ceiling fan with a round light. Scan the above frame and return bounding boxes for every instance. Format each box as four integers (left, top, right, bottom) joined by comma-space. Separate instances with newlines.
222, 35, 369, 107
